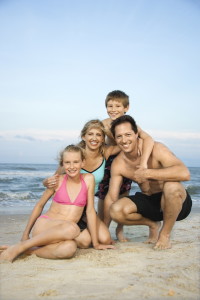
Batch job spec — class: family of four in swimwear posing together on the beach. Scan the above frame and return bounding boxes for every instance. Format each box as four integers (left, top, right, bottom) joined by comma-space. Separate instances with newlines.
0, 90, 192, 262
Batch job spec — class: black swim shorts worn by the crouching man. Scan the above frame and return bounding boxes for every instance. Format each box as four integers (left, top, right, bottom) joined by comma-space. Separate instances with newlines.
126, 191, 192, 221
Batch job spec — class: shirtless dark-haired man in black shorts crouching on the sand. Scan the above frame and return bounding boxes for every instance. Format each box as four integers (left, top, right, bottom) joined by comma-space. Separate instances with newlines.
104, 115, 192, 250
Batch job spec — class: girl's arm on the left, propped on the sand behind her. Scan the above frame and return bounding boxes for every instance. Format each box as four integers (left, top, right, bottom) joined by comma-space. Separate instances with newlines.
21, 189, 55, 241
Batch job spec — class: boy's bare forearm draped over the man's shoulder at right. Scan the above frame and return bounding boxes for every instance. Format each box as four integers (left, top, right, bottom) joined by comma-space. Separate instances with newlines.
137, 126, 154, 169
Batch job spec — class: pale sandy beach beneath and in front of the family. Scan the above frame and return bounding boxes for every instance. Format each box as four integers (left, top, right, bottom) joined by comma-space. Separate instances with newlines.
0, 211, 200, 300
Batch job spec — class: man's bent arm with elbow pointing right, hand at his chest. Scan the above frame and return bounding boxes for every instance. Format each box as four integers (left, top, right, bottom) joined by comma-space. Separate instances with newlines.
134, 143, 190, 183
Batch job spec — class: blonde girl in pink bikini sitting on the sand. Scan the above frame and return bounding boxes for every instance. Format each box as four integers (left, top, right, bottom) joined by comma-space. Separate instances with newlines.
0, 145, 114, 262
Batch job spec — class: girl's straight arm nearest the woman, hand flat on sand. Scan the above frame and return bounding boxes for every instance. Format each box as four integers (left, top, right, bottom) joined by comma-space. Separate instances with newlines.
84, 174, 114, 250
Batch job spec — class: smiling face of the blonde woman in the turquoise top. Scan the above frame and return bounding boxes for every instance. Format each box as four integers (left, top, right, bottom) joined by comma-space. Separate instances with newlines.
83, 128, 104, 150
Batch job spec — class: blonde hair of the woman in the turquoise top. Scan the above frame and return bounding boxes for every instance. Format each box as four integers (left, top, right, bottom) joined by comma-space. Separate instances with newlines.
78, 119, 106, 155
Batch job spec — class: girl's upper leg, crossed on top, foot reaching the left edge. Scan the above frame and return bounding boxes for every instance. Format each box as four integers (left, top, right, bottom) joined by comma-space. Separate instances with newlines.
0, 220, 80, 261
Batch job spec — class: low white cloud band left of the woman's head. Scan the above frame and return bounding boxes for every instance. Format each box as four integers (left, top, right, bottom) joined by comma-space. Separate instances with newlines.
0, 129, 80, 142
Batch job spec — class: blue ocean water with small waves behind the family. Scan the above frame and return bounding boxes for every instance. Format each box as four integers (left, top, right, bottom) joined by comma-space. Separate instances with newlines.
0, 164, 200, 214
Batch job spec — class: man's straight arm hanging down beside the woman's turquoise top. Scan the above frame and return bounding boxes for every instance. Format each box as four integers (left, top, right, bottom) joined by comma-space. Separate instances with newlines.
104, 159, 123, 227
